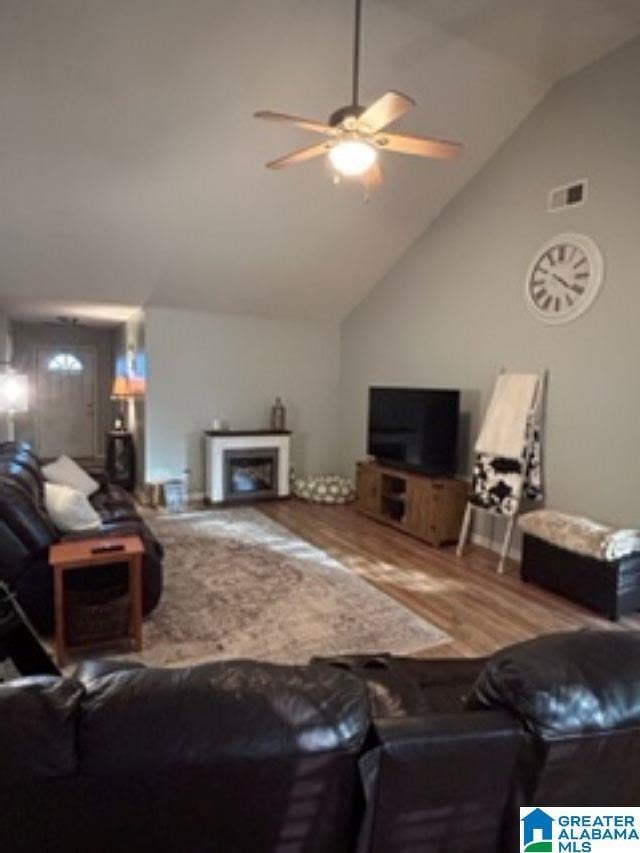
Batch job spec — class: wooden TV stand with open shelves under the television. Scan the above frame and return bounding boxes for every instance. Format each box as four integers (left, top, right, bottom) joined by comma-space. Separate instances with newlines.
356, 462, 468, 547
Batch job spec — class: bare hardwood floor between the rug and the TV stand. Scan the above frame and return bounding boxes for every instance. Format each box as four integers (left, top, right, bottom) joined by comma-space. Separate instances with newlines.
260, 499, 640, 657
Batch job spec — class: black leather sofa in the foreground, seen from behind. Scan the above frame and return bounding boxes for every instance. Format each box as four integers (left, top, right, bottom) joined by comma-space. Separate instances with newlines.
0, 631, 640, 853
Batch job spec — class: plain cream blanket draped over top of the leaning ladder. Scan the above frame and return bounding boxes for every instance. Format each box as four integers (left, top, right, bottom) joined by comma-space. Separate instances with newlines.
476, 373, 540, 459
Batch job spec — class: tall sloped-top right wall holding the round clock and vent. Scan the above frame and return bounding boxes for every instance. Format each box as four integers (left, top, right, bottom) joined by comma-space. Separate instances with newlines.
341, 40, 640, 540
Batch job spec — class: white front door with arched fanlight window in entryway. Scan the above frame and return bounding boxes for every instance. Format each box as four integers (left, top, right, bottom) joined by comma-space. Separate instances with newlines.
34, 346, 96, 458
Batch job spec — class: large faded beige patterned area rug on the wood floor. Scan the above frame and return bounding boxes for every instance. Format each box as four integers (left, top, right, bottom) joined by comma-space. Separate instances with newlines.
135, 508, 450, 666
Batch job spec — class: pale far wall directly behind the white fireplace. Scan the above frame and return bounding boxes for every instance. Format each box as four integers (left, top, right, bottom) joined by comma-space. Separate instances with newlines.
145, 308, 340, 492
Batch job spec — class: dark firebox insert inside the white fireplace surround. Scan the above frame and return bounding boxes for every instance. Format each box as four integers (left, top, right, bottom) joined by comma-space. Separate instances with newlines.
223, 447, 279, 501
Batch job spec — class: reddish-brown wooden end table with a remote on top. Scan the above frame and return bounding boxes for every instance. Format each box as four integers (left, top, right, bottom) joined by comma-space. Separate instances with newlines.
49, 536, 144, 666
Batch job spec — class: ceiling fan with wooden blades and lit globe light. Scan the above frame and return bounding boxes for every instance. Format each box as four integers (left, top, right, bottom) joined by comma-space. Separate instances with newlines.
254, 0, 463, 193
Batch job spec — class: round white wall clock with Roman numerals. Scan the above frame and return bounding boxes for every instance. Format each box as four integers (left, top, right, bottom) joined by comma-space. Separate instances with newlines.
524, 234, 604, 324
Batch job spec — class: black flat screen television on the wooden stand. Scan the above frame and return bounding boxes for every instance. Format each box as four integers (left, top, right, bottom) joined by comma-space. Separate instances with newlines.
368, 388, 460, 477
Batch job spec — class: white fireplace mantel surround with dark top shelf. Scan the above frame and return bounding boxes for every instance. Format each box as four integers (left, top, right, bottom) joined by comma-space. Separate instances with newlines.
204, 430, 291, 503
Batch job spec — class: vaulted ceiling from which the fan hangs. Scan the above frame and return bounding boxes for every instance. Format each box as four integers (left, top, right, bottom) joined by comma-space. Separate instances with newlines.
0, 0, 640, 318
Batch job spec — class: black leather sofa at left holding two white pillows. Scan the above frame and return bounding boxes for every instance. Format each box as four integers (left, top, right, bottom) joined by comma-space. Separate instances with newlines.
0, 442, 162, 634
